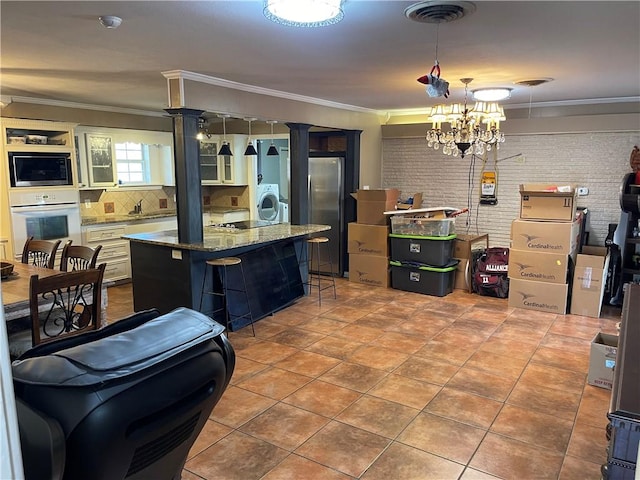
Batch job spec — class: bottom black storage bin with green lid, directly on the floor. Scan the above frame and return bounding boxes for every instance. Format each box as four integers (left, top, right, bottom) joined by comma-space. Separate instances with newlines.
389, 260, 458, 297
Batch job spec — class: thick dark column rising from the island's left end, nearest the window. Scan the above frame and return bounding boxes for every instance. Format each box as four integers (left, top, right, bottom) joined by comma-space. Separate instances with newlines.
165, 108, 203, 243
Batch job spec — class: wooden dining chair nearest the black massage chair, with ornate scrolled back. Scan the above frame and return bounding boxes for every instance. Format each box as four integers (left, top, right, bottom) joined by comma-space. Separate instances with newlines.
9, 263, 106, 359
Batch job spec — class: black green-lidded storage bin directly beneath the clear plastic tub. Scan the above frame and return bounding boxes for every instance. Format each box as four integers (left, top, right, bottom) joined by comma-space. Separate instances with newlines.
389, 233, 456, 267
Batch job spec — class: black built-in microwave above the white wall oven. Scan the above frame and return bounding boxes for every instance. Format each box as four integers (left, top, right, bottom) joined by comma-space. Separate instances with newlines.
9, 152, 73, 187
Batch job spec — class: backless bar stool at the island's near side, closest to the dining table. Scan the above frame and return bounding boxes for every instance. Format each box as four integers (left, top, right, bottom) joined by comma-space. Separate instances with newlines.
198, 257, 256, 337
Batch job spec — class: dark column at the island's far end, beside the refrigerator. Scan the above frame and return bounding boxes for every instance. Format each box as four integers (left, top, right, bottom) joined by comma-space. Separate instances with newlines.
286, 123, 313, 225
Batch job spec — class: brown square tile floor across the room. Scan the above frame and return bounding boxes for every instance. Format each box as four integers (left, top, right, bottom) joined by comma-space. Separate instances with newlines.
108, 279, 620, 480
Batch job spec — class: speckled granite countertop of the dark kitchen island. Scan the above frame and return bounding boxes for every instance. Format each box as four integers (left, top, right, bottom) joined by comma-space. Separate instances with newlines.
122, 223, 331, 252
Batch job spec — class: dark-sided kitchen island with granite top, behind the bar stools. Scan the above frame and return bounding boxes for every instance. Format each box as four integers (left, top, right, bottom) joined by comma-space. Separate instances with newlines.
123, 223, 330, 330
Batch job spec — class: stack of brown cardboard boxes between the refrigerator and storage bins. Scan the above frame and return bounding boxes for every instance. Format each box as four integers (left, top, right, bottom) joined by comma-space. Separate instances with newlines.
347, 188, 400, 287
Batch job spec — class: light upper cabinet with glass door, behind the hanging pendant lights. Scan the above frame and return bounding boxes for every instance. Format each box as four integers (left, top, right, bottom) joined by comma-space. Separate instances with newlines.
200, 135, 249, 185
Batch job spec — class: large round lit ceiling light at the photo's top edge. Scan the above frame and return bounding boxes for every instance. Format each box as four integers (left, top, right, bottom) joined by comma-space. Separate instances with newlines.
263, 0, 344, 27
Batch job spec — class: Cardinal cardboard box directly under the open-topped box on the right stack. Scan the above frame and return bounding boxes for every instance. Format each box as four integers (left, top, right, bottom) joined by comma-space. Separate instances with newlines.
511, 220, 580, 257
